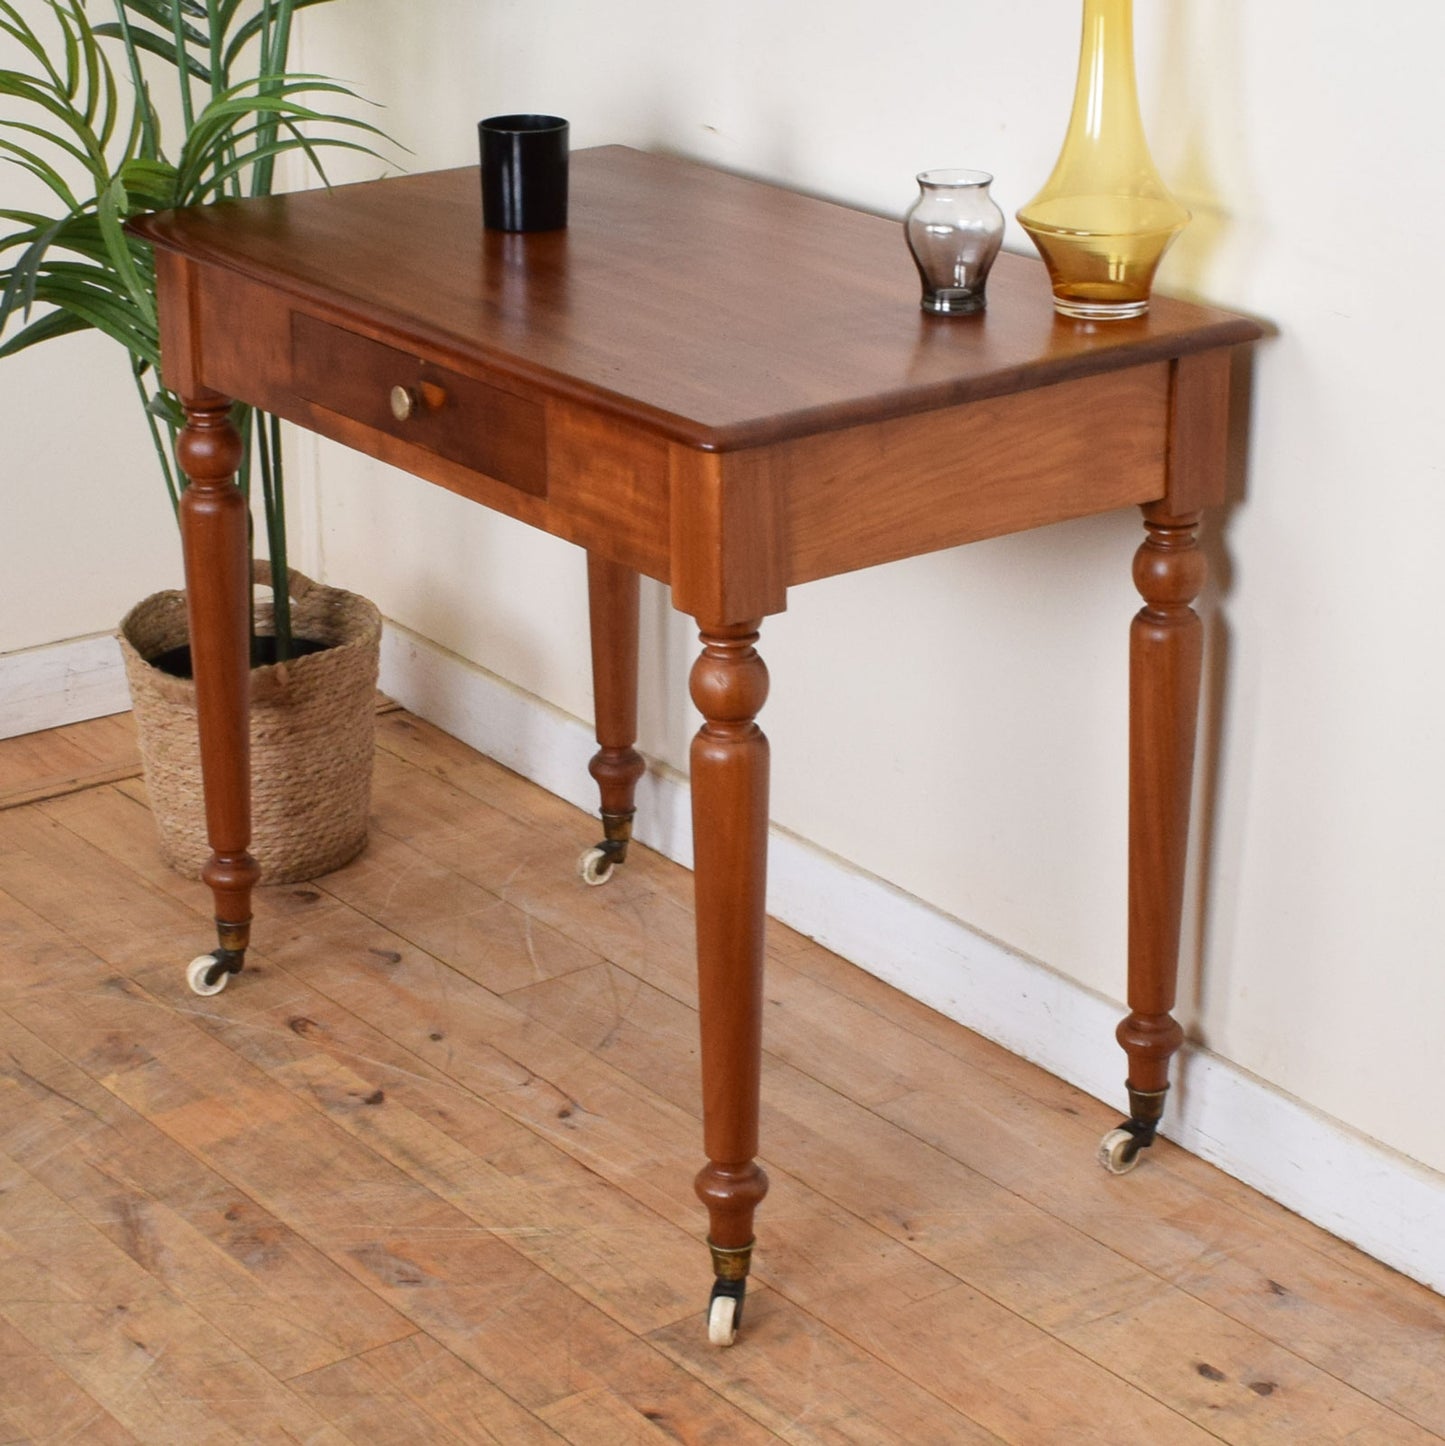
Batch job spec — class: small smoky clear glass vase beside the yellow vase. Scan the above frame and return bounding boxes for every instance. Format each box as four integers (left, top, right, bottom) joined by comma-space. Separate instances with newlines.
903, 171, 1004, 317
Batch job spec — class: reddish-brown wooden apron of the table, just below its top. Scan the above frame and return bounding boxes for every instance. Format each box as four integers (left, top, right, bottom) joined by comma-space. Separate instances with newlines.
168, 266, 1177, 620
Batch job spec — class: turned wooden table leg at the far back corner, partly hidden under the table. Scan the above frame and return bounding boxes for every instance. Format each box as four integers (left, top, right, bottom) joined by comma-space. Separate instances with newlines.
579, 552, 645, 884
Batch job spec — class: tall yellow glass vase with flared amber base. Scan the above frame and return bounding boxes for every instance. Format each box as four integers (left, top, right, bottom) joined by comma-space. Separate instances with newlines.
1018, 0, 1189, 321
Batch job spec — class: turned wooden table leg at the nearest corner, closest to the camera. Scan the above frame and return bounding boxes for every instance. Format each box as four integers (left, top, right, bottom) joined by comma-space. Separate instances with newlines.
691, 622, 768, 1345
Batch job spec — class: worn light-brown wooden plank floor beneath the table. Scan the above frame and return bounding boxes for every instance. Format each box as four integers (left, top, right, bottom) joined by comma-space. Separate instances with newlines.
0, 711, 1445, 1446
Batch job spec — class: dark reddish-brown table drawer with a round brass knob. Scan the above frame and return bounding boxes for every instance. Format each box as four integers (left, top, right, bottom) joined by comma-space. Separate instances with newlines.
291, 312, 547, 497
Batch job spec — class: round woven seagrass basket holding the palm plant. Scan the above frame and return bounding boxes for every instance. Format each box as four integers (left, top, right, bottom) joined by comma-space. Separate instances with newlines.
120, 561, 382, 884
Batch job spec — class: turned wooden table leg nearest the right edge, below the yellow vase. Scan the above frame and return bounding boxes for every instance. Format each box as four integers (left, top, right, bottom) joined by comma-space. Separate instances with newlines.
1101, 502, 1205, 1168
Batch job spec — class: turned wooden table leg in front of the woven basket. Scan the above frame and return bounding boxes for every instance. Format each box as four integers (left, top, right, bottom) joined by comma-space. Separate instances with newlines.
176, 395, 260, 993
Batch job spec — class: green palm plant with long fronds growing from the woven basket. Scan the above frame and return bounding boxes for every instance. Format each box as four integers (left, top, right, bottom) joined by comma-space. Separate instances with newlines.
0, 0, 379, 661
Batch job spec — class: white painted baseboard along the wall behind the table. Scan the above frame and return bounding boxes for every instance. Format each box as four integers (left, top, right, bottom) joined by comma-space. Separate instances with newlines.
382, 625, 1445, 1293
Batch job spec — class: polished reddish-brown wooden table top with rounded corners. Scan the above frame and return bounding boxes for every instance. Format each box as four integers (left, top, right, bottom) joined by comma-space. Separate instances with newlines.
133, 146, 1260, 451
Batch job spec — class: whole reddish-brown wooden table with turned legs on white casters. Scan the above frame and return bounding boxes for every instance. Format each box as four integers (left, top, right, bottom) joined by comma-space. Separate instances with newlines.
135, 146, 1260, 1343
